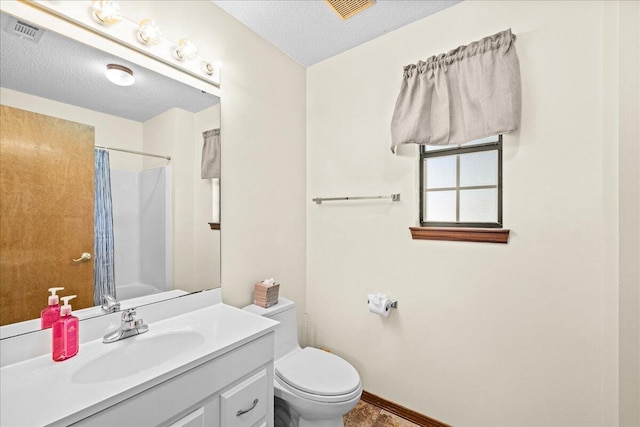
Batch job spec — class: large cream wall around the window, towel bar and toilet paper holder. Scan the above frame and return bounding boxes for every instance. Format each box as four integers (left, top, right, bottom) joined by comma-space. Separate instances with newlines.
307, 1, 637, 427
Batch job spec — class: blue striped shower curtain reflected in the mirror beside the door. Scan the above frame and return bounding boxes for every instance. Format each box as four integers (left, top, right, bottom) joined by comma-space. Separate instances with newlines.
93, 148, 116, 305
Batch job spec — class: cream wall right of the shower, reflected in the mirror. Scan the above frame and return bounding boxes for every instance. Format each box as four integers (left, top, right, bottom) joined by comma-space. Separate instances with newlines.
144, 104, 220, 292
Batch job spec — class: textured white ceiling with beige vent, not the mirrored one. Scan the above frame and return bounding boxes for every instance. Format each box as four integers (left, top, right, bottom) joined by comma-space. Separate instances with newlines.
211, 0, 461, 66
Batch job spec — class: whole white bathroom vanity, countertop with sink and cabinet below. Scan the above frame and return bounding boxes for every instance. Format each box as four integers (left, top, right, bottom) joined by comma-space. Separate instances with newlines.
0, 297, 277, 427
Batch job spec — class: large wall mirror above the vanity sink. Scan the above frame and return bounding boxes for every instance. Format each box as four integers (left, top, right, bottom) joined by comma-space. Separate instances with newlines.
0, 14, 220, 338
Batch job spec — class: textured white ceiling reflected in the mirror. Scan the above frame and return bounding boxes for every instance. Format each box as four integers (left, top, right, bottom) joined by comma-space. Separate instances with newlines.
0, 14, 220, 122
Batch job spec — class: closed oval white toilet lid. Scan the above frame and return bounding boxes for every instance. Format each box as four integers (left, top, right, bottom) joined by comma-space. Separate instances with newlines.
275, 347, 360, 396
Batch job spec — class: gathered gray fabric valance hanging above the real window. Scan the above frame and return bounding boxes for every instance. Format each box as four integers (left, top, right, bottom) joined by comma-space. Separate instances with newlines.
391, 29, 520, 153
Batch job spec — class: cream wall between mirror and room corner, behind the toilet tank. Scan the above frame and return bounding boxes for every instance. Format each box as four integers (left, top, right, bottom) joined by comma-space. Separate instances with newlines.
121, 1, 306, 322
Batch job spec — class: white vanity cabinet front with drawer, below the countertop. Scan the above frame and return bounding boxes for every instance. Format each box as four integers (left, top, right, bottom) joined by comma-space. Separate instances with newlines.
74, 332, 273, 427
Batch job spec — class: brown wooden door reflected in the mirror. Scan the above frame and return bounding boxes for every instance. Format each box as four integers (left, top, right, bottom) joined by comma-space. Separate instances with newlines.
0, 105, 94, 325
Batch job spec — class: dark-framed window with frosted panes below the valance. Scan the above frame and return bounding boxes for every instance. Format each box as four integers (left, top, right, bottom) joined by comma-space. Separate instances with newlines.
420, 135, 502, 228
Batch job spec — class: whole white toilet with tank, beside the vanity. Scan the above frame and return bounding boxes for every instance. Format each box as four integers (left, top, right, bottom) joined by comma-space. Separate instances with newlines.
244, 297, 362, 427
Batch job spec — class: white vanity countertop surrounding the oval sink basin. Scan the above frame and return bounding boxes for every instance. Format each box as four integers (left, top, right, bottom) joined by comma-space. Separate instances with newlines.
0, 304, 277, 427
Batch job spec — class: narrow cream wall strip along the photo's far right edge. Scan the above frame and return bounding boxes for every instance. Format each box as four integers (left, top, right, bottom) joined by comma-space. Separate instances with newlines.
614, 1, 640, 427
